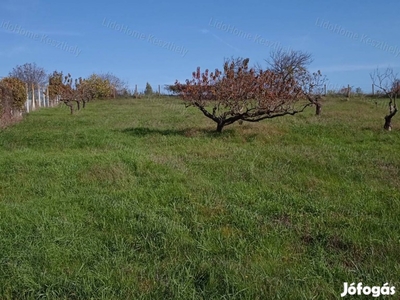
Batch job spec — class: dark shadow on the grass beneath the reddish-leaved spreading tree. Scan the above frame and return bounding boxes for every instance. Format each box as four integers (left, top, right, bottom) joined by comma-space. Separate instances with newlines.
121, 127, 235, 138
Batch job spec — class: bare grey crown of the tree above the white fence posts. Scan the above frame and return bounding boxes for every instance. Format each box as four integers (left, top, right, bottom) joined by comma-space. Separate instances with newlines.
9, 63, 48, 87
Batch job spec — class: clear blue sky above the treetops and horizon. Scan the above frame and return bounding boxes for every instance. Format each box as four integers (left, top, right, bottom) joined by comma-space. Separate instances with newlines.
0, 0, 400, 92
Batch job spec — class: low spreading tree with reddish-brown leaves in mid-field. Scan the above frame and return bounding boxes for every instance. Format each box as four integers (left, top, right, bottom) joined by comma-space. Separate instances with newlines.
175, 52, 322, 132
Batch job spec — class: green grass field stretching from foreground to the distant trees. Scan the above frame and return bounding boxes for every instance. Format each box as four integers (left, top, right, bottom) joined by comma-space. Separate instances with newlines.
0, 99, 400, 299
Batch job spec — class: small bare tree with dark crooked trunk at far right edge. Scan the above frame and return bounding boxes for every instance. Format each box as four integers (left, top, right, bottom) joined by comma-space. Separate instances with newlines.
370, 68, 400, 131
